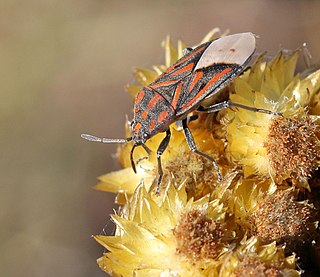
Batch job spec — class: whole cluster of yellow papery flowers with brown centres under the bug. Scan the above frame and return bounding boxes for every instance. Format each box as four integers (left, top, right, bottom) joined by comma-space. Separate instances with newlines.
95, 29, 320, 276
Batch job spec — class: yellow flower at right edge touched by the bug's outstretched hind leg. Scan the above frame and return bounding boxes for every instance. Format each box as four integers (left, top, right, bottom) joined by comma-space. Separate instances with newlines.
221, 51, 320, 188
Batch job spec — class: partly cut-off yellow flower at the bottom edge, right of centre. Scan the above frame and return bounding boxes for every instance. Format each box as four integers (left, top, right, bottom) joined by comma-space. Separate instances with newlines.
219, 237, 300, 277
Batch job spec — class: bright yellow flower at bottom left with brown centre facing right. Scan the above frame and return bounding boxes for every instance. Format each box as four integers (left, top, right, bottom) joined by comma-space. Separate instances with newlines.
95, 181, 236, 276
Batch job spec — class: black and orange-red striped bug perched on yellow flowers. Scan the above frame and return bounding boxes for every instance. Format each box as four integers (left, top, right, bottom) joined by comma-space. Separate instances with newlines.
81, 33, 278, 193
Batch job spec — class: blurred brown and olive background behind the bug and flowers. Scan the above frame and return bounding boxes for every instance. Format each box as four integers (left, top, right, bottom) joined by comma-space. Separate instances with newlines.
0, 0, 320, 277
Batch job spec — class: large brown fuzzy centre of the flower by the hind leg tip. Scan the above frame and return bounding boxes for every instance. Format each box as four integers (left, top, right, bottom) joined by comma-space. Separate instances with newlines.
264, 117, 320, 183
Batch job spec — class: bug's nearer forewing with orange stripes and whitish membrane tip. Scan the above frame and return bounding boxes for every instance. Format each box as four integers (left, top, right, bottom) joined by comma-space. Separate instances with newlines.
175, 33, 255, 116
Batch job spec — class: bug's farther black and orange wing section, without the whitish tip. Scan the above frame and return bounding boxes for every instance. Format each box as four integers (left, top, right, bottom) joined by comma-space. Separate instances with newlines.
148, 42, 211, 104
